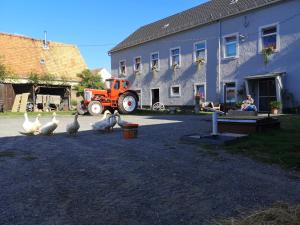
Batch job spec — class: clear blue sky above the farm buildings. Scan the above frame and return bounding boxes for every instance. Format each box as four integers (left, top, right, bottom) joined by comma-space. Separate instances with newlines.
0, 0, 206, 70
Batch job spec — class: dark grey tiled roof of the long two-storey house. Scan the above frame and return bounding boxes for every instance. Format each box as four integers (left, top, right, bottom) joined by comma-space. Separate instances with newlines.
110, 0, 284, 53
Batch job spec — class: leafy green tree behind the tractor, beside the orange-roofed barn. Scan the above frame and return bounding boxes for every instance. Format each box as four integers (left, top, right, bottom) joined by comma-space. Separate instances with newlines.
74, 69, 104, 96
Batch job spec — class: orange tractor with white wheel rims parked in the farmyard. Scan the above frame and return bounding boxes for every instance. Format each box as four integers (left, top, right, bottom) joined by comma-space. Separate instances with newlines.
77, 78, 139, 116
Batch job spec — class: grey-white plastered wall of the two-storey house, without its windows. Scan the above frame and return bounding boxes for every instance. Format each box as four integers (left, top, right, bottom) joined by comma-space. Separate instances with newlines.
111, 0, 300, 109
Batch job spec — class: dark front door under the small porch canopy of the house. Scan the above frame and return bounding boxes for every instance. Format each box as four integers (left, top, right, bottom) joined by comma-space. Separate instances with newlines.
259, 78, 277, 112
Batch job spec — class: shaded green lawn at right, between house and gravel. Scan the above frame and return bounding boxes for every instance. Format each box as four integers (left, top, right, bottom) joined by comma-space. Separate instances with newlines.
224, 115, 300, 170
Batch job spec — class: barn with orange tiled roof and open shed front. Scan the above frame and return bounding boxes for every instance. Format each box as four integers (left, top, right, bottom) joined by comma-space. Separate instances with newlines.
0, 33, 87, 111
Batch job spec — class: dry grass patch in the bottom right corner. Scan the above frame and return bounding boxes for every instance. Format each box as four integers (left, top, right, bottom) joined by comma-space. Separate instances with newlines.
215, 203, 300, 225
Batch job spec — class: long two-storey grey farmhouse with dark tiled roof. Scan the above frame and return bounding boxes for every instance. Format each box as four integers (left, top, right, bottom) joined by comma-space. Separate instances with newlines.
109, 0, 300, 112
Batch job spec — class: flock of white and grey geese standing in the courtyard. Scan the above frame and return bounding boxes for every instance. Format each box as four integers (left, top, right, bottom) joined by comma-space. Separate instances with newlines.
20, 110, 128, 136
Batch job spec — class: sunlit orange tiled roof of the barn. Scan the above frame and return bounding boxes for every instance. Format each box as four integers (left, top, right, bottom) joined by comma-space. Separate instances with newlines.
0, 33, 87, 81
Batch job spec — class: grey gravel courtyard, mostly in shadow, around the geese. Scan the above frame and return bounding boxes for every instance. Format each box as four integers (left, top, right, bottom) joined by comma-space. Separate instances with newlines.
0, 116, 300, 225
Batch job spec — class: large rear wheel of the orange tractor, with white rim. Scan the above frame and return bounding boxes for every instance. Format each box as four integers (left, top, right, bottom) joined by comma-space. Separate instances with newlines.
118, 92, 138, 114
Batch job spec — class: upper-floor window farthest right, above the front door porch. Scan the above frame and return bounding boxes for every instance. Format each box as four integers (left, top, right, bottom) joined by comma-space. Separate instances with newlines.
260, 24, 279, 50
